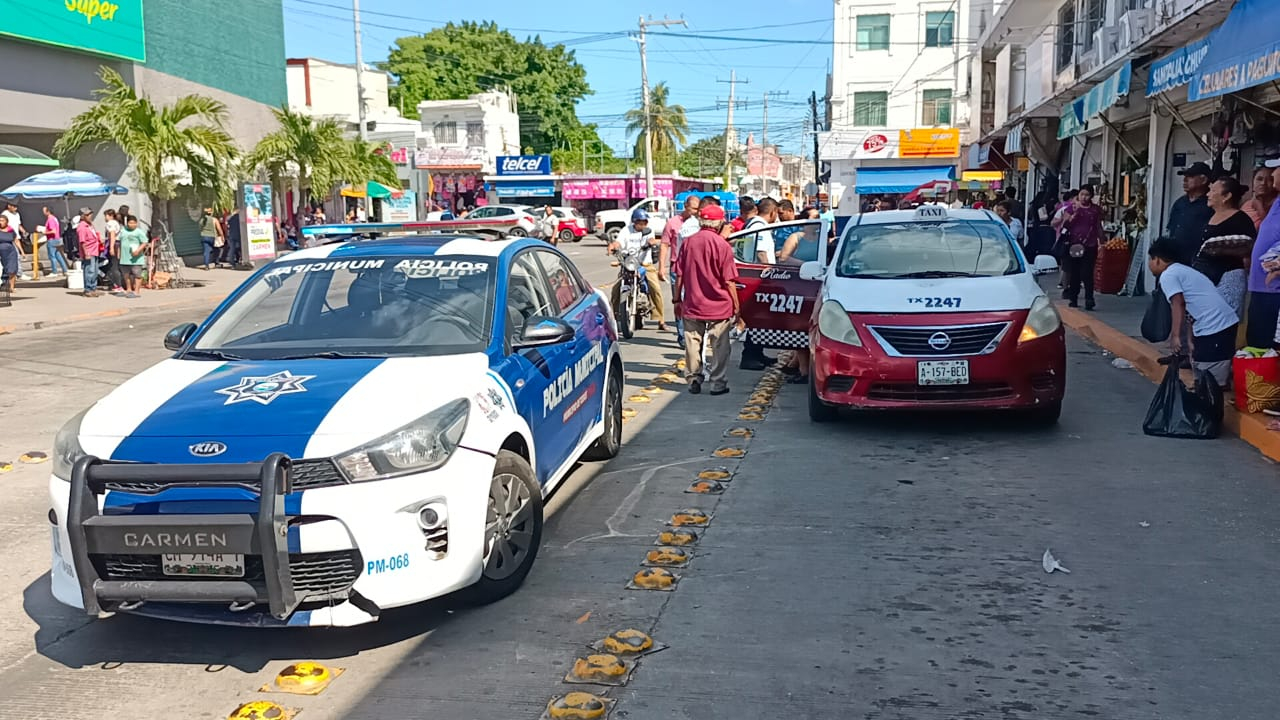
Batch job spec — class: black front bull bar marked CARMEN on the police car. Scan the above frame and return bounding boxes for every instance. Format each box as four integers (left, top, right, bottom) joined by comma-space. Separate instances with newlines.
67, 454, 300, 620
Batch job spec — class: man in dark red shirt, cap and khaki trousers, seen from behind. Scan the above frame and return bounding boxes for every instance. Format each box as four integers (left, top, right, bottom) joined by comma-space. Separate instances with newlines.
676, 205, 739, 395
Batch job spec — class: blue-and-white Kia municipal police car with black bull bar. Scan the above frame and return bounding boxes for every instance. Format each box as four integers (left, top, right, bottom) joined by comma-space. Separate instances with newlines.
50, 225, 623, 625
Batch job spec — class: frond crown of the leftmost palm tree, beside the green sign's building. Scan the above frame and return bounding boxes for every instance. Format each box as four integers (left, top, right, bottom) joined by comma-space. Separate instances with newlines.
54, 67, 238, 229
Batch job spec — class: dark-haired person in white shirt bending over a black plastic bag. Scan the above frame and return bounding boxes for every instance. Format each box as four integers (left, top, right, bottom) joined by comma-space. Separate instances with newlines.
1147, 240, 1240, 388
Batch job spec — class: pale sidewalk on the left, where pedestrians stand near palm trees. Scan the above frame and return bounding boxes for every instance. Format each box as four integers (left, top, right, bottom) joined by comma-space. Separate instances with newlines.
0, 268, 248, 336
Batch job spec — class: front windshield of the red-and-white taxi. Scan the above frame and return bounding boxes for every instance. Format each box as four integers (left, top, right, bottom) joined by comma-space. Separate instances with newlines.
836, 220, 1023, 279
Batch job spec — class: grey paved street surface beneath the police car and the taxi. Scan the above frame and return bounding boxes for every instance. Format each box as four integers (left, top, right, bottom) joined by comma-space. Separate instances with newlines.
0, 245, 1280, 720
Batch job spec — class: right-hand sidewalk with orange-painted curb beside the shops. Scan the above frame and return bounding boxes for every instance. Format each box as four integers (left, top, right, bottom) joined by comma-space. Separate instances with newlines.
1042, 282, 1280, 461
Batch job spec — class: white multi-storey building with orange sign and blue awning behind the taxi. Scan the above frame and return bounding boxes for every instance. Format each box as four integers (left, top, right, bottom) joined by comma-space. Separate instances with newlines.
820, 0, 989, 215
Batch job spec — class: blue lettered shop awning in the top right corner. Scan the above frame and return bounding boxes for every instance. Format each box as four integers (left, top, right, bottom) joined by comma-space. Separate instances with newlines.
1187, 0, 1280, 101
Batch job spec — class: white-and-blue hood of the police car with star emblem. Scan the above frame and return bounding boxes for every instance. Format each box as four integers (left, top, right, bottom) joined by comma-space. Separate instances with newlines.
79, 354, 488, 462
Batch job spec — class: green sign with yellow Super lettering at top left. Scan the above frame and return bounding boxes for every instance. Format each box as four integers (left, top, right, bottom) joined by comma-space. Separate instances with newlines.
0, 0, 147, 63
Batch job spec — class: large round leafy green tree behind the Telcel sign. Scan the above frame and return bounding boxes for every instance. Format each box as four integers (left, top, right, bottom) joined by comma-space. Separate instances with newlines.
381, 22, 591, 152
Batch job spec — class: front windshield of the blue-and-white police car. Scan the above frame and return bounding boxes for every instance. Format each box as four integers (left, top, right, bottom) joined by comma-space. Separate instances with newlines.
192, 255, 494, 360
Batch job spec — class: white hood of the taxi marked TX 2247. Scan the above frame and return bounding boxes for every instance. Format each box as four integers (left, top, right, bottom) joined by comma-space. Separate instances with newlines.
824, 273, 1044, 315
